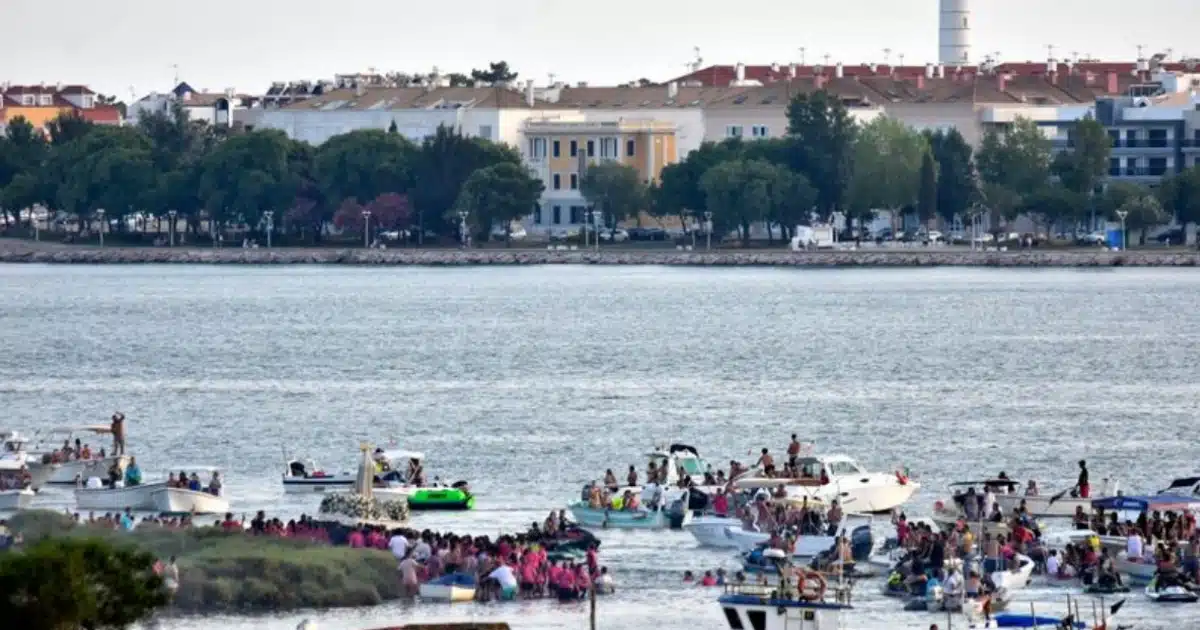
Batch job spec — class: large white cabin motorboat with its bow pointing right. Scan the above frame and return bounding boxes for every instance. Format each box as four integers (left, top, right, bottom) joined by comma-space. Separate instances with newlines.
738, 455, 920, 514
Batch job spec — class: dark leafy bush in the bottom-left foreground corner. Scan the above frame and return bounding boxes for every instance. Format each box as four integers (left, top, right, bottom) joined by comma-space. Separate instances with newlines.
0, 538, 169, 630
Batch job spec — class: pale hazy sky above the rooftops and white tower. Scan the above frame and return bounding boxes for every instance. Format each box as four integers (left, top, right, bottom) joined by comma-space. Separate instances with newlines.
0, 0, 1200, 101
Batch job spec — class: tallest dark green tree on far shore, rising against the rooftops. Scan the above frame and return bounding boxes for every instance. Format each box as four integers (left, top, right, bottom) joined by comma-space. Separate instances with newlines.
787, 90, 858, 217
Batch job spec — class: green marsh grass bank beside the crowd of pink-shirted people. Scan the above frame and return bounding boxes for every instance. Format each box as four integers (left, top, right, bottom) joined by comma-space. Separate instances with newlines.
10, 510, 401, 613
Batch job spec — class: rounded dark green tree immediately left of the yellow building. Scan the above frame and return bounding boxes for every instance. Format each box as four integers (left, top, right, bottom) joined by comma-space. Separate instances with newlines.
446, 162, 544, 239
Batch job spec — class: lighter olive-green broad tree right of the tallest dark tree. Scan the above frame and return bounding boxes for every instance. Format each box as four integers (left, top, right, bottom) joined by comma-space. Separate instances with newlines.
845, 116, 928, 228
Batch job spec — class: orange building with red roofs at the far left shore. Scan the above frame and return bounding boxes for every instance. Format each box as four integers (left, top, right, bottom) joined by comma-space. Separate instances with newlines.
0, 84, 121, 133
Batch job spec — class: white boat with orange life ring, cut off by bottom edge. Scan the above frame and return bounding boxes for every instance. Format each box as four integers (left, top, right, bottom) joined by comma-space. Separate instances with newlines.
718, 550, 852, 630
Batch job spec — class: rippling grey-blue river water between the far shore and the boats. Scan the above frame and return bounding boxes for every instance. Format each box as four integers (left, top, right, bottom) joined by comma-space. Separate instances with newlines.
0, 265, 1200, 630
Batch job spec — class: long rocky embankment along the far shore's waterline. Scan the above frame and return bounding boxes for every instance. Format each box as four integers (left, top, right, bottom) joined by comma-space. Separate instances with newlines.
0, 240, 1200, 268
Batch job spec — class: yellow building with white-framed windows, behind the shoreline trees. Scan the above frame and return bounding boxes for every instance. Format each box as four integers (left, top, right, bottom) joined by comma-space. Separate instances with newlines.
522, 119, 679, 234
